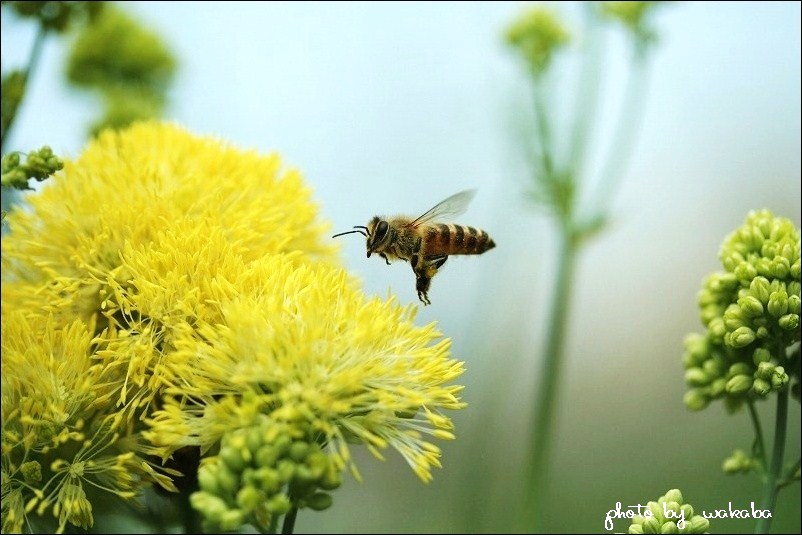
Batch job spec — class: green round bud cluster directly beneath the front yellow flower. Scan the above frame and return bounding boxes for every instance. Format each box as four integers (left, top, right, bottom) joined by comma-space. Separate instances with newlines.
190, 418, 342, 532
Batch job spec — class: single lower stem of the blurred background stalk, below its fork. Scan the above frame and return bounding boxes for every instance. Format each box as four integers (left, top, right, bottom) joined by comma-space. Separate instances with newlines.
526, 229, 577, 532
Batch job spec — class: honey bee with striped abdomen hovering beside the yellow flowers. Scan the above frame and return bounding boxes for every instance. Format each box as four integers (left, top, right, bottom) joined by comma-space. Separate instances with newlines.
332, 190, 496, 305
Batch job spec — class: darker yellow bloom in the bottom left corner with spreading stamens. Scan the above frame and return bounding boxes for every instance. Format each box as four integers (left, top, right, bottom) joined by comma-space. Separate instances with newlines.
2, 307, 172, 533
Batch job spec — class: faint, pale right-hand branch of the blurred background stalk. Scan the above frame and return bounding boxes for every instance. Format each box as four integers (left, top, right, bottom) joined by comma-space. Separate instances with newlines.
591, 41, 648, 219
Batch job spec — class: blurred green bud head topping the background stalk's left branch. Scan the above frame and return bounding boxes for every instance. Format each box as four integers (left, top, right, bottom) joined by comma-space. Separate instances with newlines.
506, 7, 570, 76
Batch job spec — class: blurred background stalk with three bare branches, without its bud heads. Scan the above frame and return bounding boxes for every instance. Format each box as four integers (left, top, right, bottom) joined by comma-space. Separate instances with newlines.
522, 5, 649, 532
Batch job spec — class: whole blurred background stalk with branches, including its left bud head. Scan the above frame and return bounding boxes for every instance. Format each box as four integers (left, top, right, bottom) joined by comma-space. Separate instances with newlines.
506, 3, 664, 531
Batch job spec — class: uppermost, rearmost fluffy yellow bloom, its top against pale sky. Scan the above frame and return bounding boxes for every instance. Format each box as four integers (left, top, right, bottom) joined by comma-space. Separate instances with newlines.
3, 123, 335, 418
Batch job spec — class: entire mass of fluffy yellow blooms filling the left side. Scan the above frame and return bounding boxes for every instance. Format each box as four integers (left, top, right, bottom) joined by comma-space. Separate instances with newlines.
2, 123, 464, 532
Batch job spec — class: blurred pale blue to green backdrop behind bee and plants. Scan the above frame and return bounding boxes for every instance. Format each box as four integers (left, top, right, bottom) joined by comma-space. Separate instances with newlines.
2, 2, 802, 533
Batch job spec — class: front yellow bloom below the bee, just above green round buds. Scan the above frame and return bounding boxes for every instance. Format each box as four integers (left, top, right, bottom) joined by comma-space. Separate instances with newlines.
147, 255, 464, 481
